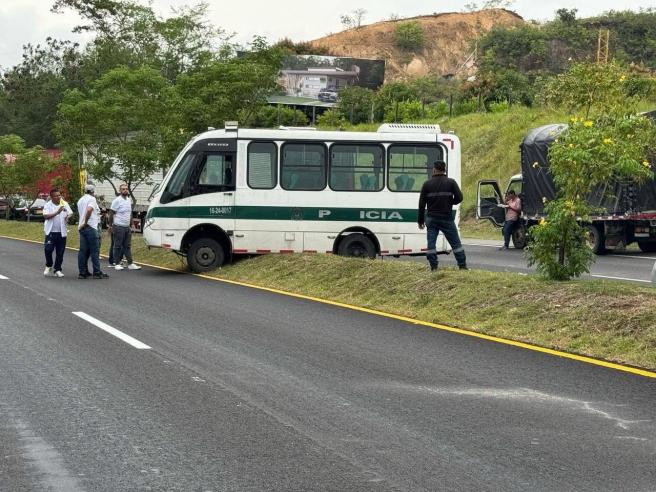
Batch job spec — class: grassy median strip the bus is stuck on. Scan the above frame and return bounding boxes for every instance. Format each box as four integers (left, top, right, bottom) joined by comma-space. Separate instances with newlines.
0, 221, 656, 369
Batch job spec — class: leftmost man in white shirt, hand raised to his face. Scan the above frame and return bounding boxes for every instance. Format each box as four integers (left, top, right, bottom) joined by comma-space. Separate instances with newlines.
43, 189, 73, 278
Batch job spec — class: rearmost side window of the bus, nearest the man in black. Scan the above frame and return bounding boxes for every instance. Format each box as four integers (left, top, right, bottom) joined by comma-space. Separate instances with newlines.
387, 145, 444, 192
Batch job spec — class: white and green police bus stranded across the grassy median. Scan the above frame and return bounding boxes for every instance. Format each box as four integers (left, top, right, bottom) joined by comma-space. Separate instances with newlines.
143, 123, 460, 272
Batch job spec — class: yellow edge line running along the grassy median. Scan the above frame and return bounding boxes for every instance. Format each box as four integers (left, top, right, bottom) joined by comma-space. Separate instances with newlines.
0, 236, 656, 378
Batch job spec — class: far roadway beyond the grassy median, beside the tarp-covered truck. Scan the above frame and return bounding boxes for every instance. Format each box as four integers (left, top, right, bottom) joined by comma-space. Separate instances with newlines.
402, 239, 656, 284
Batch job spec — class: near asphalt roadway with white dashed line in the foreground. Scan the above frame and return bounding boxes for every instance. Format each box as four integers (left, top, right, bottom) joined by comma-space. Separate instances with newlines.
0, 239, 656, 492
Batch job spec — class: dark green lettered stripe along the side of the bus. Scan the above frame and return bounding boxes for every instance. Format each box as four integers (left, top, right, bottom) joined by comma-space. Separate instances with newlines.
147, 206, 426, 222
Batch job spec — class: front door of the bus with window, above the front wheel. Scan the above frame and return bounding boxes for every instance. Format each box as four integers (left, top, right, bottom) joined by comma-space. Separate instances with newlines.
189, 150, 237, 235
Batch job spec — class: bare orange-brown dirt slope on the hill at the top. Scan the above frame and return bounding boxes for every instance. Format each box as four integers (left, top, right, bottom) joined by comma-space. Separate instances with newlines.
310, 9, 525, 81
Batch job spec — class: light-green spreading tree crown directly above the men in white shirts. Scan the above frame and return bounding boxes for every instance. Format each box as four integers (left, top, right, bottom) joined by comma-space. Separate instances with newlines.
56, 68, 179, 201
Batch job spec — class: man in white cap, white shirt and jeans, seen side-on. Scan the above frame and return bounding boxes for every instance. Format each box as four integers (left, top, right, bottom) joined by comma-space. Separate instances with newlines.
77, 184, 108, 279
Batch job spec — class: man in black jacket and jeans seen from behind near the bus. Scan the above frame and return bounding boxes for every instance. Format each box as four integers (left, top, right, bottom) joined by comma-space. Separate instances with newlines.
418, 161, 468, 271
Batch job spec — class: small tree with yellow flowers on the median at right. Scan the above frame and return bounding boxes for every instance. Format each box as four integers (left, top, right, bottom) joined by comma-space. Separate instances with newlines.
527, 63, 656, 280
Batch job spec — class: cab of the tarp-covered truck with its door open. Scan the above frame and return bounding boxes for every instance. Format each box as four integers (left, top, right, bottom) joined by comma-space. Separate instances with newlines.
476, 174, 526, 249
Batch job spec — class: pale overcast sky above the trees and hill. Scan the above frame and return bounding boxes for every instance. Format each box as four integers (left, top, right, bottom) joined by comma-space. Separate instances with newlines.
0, 0, 656, 69
